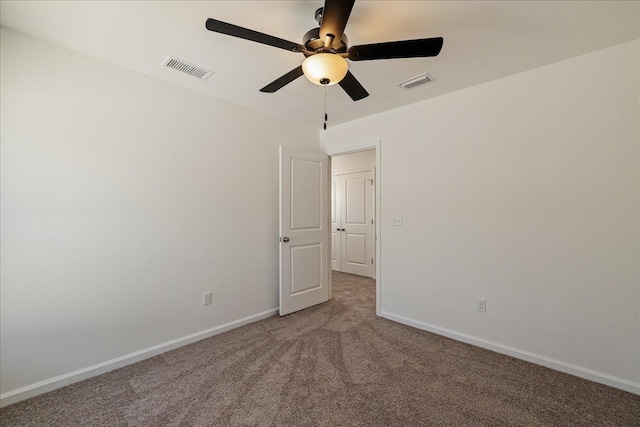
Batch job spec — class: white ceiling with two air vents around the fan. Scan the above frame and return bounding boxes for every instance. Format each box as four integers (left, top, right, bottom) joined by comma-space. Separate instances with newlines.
0, 0, 640, 128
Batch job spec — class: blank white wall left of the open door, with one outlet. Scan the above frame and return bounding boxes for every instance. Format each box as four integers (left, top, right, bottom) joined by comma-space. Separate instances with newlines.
0, 29, 318, 402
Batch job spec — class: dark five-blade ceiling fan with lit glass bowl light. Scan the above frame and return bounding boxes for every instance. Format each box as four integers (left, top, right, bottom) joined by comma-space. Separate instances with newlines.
206, 0, 443, 101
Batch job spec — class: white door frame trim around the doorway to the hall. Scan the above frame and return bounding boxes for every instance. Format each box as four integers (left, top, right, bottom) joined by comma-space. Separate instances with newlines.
325, 140, 382, 316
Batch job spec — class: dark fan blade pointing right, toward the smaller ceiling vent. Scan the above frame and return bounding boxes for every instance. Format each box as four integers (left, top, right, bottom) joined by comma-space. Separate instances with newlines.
348, 37, 444, 61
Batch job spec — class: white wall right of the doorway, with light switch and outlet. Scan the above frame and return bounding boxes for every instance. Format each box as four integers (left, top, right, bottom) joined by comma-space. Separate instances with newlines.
320, 40, 640, 393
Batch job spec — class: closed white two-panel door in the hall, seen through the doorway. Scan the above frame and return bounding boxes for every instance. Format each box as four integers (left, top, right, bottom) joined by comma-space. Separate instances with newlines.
341, 171, 375, 277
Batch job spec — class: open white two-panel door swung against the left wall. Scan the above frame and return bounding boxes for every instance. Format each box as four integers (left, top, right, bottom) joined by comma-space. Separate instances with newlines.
280, 146, 331, 316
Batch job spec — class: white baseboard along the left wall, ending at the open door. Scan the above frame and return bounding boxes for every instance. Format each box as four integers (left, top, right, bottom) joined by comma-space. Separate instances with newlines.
0, 308, 278, 408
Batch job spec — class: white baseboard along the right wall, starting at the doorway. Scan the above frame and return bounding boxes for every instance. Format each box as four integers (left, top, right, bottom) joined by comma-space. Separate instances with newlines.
378, 311, 640, 395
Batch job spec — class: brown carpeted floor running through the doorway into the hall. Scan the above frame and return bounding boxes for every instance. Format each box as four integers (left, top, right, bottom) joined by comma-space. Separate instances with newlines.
0, 273, 640, 426
